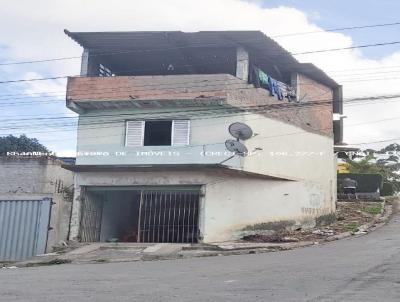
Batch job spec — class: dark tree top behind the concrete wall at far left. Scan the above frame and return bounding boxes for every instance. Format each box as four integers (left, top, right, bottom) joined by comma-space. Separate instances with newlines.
0, 134, 50, 155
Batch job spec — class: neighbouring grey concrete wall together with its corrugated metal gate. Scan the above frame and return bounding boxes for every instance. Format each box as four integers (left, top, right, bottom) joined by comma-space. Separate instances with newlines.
0, 156, 73, 261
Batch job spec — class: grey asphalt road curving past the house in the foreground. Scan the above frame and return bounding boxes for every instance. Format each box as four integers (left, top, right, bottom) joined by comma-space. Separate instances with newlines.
0, 214, 400, 302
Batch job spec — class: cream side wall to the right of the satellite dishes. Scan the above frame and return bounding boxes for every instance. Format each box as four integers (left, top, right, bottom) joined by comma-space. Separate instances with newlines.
239, 116, 336, 217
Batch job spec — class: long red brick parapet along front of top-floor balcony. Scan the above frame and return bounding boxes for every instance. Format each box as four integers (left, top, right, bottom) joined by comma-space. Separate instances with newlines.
67, 74, 247, 101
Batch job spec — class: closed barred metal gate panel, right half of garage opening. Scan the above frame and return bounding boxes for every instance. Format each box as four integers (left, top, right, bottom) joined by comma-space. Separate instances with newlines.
139, 190, 200, 243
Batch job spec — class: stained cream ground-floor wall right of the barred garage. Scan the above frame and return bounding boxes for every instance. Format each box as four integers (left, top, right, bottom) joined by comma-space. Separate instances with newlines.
204, 177, 334, 242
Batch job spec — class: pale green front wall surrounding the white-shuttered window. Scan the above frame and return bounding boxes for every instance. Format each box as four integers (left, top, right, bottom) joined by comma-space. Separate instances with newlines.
76, 107, 241, 167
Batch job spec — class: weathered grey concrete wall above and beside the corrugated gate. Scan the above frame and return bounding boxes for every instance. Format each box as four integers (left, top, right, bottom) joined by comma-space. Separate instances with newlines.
0, 157, 73, 252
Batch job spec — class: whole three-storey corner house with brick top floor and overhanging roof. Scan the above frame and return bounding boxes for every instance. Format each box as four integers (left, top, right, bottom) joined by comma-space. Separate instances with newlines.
65, 31, 342, 242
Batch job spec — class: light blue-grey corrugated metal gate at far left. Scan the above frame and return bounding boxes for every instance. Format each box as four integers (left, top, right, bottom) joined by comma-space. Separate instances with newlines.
0, 198, 51, 261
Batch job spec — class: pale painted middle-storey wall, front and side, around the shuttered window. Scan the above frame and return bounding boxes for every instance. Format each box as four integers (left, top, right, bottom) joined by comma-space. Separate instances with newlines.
77, 110, 335, 182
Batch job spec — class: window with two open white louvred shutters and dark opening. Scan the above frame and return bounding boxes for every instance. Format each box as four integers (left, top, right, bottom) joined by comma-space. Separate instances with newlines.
125, 120, 190, 147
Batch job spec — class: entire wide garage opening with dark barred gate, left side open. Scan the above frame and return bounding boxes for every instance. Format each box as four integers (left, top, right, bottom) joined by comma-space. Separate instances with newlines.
79, 187, 200, 243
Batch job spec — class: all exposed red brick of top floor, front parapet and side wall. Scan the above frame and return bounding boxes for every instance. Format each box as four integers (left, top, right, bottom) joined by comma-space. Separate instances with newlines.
67, 74, 333, 136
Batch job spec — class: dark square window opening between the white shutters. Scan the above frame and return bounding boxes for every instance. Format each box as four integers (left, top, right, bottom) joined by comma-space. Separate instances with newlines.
144, 121, 172, 146
